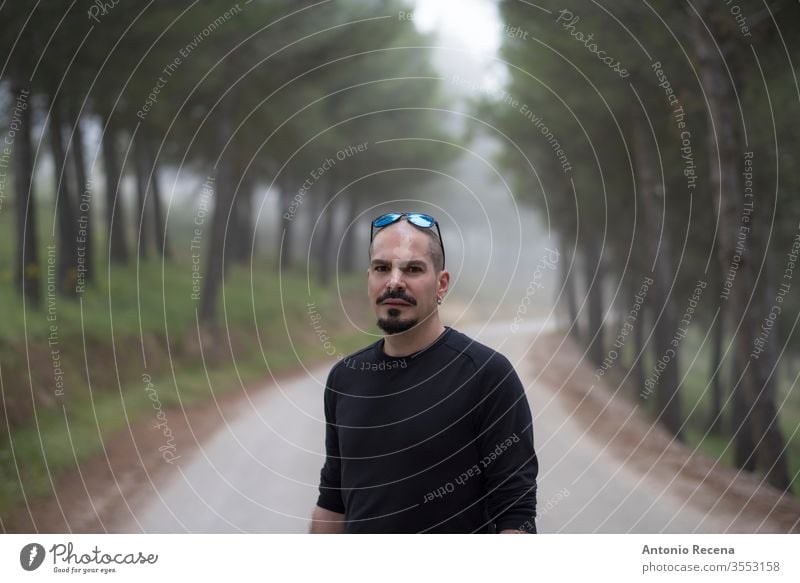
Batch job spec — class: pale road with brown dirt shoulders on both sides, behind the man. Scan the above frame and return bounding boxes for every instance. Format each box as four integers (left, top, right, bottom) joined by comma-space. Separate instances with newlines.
6, 321, 800, 533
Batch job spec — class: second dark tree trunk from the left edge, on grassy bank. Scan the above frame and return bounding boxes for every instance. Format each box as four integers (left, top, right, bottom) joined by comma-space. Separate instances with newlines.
49, 98, 78, 294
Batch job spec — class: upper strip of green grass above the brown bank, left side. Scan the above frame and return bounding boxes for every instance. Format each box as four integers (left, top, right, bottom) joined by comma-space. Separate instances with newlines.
0, 258, 346, 345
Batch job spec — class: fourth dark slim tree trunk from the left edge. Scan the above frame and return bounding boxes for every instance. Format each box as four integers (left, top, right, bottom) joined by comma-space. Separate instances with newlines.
102, 114, 129, 263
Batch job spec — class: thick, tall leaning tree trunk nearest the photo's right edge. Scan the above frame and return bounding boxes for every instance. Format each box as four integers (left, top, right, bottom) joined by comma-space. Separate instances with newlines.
690, 0, 791, 490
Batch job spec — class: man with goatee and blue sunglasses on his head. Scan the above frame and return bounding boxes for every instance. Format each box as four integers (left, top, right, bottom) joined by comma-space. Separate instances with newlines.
311, 213, 538, 533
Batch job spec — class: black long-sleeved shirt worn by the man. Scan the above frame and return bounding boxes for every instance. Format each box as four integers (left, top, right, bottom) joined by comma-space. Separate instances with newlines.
317, 328, 538, 533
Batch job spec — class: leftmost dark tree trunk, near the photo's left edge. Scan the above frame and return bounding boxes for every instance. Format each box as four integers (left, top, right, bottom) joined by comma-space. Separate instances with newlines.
13, 84, 42, 306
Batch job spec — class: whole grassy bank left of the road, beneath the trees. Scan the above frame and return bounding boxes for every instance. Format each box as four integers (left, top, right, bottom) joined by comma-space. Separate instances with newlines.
0, 208, 371, 517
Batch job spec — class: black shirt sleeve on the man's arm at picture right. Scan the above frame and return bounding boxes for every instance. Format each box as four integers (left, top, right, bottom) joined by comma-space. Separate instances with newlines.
476, 353, 539, 533
